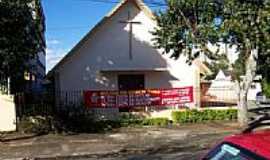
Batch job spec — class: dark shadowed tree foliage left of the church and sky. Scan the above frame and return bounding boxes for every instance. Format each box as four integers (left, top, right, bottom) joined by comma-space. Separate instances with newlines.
0, 0, 44, 92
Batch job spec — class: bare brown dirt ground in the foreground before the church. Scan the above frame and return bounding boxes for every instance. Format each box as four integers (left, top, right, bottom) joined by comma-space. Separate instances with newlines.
0, 123, 239, 160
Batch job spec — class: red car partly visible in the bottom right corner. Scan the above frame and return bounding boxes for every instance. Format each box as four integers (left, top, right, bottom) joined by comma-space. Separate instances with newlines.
202, 108, 270, 160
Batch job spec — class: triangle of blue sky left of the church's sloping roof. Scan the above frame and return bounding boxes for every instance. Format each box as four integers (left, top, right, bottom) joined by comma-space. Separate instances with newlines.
42, 0, 166, 71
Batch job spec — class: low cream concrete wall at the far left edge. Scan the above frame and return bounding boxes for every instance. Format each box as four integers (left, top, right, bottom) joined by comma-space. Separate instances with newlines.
0, 94, 16, 132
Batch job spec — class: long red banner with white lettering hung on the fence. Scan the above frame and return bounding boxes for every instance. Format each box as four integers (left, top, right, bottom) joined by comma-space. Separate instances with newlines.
84, 87, 193, 108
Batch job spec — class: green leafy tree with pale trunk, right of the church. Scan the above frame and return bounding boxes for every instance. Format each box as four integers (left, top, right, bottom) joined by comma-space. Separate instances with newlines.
153, 0, 270, 126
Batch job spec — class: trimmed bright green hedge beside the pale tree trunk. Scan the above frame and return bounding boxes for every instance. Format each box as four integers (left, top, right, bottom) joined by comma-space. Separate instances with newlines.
172, 109, 237, 123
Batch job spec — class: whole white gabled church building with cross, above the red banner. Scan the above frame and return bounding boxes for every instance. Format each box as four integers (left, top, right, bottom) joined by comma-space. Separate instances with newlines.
47, 0, 209, 109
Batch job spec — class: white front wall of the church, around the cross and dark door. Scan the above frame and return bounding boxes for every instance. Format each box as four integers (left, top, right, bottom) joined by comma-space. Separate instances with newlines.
54, 0, 199, 106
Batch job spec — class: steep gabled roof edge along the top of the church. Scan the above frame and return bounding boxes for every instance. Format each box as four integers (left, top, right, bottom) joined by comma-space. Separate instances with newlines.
47, 0, 155, 78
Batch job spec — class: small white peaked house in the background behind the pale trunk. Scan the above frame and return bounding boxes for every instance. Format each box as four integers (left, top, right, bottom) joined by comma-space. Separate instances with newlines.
206, 70, 262, 103
